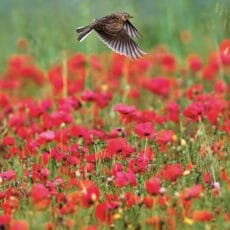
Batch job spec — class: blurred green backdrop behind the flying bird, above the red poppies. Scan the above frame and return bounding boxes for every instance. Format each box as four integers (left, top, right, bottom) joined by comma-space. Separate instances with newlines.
0, 0, 230, 68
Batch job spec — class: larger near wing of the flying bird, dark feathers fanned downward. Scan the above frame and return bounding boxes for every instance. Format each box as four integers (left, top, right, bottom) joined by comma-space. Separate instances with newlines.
95, 29, 145, 59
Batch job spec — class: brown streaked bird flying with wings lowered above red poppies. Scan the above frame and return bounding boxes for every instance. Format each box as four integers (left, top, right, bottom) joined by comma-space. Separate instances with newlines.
76, 12, 146, 59
